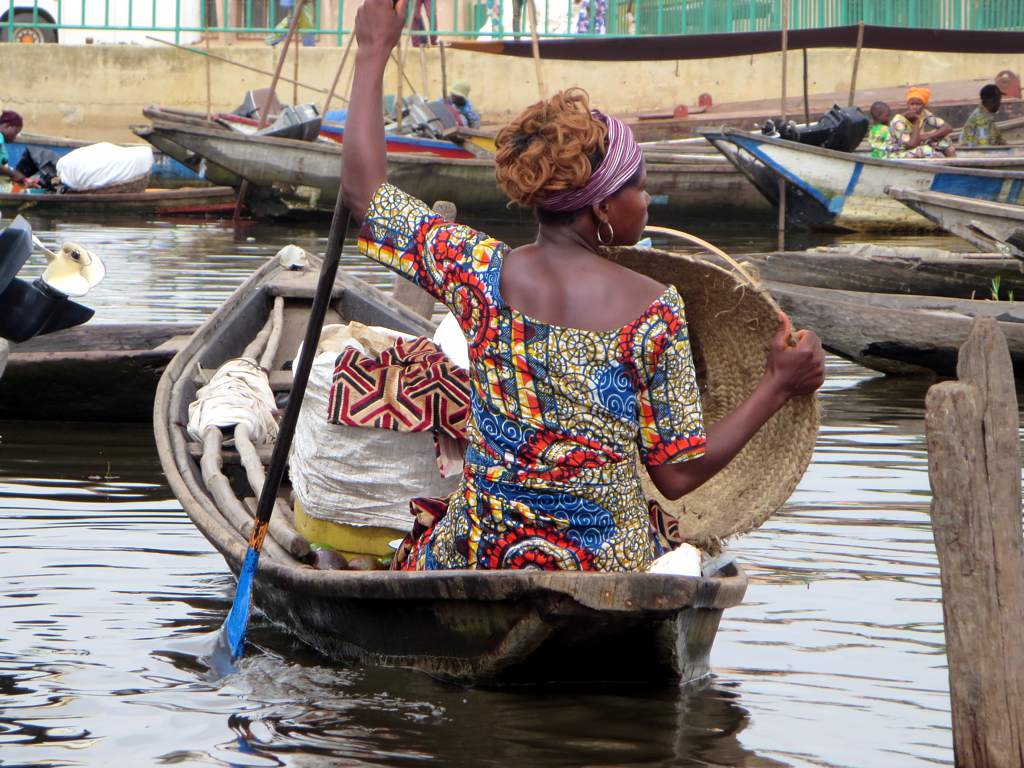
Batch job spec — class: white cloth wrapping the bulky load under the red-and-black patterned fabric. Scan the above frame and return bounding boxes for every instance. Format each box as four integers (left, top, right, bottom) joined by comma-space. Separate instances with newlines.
289, 323, 459, 530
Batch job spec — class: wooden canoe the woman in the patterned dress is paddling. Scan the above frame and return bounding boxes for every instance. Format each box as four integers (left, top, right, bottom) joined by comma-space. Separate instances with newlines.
154, 256, 746, 684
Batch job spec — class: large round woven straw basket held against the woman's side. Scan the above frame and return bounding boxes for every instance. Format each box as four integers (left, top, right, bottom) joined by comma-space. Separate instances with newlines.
604, 248, 819, 549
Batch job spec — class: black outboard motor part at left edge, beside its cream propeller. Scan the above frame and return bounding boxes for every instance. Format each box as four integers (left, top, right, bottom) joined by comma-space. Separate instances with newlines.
0, 216, 101, 342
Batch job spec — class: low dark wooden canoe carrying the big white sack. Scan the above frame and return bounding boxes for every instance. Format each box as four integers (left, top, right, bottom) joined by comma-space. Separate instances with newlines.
0, 186, 234, 216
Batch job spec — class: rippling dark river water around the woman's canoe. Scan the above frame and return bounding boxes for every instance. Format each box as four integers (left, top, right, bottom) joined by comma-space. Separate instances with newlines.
0, 210, 991, 768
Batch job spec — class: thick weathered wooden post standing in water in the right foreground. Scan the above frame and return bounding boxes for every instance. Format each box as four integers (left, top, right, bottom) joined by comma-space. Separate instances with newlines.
925, 317, 1024, 768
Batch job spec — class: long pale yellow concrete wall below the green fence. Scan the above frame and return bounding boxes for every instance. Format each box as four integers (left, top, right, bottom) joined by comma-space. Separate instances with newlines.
0, 44, 1024, 141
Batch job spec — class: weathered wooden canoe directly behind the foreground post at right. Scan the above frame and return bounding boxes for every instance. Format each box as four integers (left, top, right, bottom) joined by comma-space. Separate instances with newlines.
766, 283, 1024, 377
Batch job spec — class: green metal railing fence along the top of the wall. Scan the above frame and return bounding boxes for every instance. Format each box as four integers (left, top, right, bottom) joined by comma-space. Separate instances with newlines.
0, 0, 1024, 44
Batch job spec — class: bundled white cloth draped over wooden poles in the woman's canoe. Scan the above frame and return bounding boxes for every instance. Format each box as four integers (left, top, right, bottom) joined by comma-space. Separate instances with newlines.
188, 357, 278, 444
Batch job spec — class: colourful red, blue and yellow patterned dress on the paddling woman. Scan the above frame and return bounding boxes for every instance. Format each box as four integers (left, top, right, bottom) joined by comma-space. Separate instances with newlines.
359, 184, 705, 570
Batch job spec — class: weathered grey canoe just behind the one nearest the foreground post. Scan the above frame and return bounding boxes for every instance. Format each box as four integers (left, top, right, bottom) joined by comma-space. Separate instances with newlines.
708, 244, 1024, 299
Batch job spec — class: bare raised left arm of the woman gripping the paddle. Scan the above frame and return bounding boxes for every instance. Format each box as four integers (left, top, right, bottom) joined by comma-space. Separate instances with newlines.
341, 0, 409, 221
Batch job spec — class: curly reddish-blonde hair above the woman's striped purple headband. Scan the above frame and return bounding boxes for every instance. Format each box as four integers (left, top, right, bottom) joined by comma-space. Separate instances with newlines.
495, 88, 608, 207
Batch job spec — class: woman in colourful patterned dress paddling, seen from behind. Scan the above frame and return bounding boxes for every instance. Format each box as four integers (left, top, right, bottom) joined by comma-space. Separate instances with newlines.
342, 0, 824, 570
